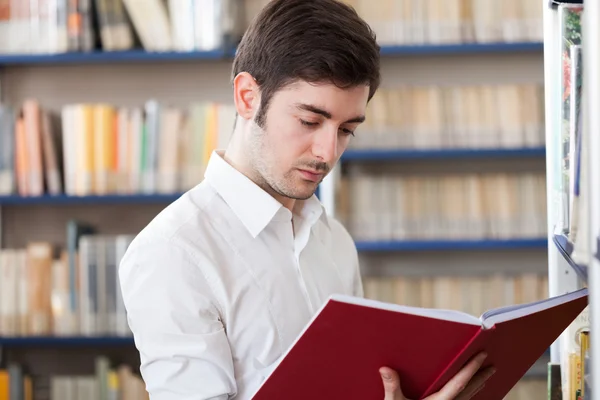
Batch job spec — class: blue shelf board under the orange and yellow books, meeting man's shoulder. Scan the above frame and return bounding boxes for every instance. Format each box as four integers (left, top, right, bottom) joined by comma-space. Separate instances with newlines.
0, 194, 181, 206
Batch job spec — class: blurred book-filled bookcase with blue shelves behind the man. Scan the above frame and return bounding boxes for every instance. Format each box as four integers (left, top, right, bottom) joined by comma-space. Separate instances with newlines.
0, 0, 548, 400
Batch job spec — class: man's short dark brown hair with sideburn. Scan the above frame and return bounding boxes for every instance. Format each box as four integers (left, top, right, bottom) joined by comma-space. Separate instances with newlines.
232, 0, 381, 127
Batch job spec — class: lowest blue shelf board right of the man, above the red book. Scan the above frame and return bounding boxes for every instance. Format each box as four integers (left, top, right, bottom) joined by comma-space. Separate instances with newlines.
356, 238, 548, 252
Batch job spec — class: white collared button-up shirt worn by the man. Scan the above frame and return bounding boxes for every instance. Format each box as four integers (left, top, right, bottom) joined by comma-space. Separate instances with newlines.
119, 152, 363, 400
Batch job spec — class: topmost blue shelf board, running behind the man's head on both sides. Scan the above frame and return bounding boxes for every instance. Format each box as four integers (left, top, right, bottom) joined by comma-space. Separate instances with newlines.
0, 42, 544, 66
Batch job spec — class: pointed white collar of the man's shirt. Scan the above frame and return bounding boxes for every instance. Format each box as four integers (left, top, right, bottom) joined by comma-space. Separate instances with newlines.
204, 150, 329, 237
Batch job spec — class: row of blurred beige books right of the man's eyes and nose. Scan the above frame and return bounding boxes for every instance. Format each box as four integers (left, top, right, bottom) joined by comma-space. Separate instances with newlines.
350, 83, 545, 148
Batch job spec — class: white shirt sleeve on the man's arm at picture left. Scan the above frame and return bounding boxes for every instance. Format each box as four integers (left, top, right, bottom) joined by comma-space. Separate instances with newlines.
119, 239, 236, 400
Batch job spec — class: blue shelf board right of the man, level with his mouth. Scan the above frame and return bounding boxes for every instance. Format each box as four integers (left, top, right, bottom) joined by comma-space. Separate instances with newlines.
341, 147, 546, 161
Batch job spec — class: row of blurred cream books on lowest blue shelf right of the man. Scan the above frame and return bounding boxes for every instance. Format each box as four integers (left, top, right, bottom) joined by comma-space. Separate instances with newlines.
336, 172, 547, 240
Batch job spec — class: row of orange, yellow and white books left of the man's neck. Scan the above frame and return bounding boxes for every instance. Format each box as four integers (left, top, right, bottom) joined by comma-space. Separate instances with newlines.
0, 99, 235, 196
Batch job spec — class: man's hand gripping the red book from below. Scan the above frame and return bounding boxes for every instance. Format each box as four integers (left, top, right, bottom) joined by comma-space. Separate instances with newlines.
379, 353, 495, 400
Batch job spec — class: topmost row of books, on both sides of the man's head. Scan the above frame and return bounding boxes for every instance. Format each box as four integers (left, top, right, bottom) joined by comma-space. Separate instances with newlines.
0, 0, 543, 53
